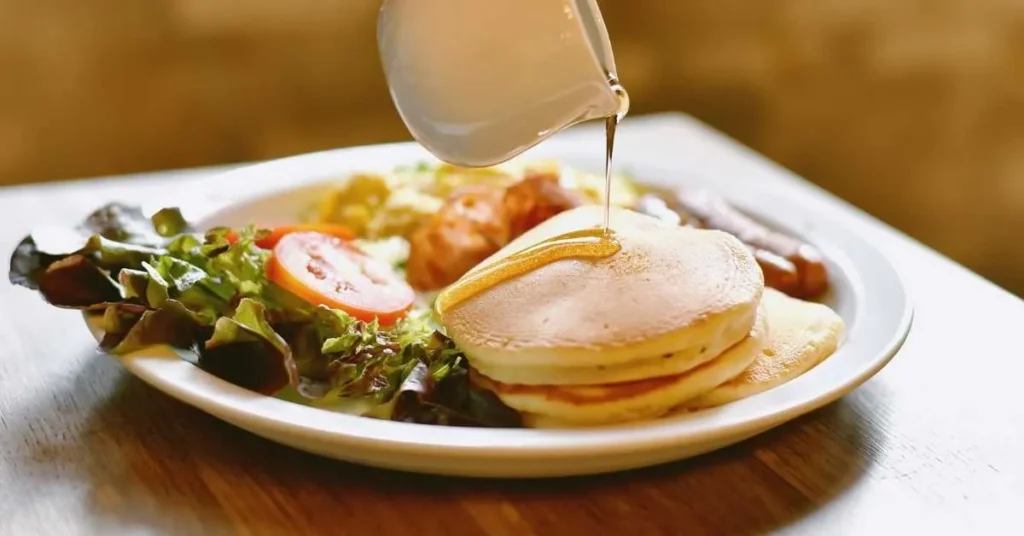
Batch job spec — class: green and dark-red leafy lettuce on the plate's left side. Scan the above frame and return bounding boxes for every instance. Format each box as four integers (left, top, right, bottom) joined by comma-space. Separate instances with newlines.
9, 203, 520, 426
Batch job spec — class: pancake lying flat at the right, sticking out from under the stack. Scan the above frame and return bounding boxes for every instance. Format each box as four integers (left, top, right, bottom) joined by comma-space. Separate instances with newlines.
685, 288, 844, 409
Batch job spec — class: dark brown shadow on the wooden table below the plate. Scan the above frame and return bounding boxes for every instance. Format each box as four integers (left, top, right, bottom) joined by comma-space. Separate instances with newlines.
12, 356, 885, 534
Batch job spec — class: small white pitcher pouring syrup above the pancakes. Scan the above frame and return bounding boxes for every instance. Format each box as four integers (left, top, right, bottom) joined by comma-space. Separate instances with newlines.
377, 0, 628, 167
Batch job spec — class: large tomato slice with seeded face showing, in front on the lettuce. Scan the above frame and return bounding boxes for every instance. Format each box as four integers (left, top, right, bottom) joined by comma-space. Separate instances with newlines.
267, 232, 416, 326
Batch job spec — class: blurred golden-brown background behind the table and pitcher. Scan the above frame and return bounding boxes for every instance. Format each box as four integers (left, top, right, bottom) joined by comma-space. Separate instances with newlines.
0, 0, 1024, 295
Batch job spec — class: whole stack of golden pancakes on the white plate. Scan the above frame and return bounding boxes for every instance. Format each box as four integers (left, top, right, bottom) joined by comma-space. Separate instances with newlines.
441, 205, 843, 426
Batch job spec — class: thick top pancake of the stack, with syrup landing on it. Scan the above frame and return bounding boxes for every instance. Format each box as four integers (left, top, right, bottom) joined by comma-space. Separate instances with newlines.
441, 205, 764, 367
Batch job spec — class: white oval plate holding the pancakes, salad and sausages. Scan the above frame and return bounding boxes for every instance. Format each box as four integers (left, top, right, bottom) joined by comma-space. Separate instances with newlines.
79, 139, 912, 477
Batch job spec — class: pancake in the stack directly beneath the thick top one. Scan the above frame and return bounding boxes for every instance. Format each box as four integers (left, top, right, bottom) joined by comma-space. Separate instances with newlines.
474, 315, 767, 425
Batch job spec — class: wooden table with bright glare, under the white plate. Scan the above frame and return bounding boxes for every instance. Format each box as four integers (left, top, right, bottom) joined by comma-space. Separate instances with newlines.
0, 115, 1024, 536
